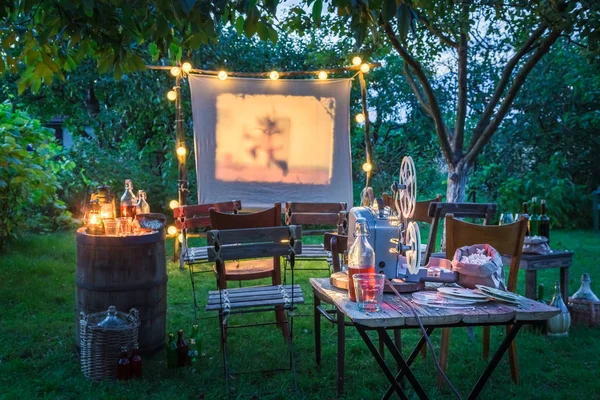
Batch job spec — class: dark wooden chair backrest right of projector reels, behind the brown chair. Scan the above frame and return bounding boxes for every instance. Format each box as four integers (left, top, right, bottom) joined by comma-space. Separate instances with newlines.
423, 202, 496, 265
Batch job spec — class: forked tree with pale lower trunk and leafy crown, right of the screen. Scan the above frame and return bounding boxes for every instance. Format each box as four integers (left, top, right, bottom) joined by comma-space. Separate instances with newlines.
290, 0, 598, 201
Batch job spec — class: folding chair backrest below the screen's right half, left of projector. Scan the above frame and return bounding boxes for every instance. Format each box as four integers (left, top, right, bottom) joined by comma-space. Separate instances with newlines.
285, 201, 348, 235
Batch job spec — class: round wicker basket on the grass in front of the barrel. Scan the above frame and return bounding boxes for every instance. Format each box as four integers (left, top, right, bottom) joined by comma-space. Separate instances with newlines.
79, 308, 140, 381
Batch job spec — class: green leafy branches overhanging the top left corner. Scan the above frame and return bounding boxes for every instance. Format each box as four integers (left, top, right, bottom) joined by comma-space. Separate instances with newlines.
0, 0, 279, 93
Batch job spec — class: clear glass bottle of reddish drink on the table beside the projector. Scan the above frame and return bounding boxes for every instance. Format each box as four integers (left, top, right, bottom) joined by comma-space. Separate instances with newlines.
348, 218, 375, 301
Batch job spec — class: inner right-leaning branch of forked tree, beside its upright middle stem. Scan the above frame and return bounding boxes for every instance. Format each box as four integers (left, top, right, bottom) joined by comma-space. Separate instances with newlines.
469, 23, 548, 147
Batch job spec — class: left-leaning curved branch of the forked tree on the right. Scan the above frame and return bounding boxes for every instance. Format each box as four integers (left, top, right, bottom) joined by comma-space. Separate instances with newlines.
383, 22, 455, 165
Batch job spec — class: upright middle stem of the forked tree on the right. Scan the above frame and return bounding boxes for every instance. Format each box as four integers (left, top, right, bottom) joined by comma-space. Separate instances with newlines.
452, 2, 469, 158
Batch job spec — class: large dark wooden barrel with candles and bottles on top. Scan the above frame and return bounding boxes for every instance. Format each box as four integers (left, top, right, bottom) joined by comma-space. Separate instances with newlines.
75, 228, 167, 353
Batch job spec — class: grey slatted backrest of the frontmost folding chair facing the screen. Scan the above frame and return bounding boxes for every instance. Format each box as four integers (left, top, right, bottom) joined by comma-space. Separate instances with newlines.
206, 225, 302, 265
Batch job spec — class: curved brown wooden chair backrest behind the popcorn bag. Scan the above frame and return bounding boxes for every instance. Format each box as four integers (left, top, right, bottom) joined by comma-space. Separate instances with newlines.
445, 214, 528, 292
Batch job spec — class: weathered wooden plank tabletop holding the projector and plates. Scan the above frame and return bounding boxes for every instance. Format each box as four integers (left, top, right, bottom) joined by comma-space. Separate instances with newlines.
310, 278, 560, 328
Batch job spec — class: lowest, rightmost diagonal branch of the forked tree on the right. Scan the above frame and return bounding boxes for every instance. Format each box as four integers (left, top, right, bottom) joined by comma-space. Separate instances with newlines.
466, 30, 561, 162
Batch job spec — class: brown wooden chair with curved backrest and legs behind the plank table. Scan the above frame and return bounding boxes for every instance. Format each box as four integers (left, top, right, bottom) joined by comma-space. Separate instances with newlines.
438, 214, 528, 387
